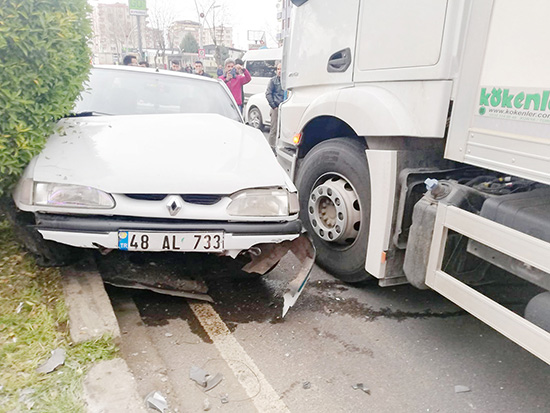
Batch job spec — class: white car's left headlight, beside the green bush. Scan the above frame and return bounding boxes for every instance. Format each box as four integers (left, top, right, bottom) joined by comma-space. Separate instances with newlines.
33, 182, 115, 209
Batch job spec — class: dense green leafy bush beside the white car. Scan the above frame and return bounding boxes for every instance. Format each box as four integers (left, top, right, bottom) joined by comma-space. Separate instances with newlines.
0, 0, 91, 194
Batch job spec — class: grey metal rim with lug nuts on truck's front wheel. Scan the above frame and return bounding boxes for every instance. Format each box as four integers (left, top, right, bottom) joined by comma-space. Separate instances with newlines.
307, 174, 361, 247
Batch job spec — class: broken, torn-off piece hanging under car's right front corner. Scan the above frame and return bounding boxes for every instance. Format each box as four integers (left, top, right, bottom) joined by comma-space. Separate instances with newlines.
243, 233, 315, 317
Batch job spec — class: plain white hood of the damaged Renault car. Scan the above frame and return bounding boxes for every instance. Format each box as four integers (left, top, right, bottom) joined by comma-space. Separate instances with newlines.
33, 114, 286, 194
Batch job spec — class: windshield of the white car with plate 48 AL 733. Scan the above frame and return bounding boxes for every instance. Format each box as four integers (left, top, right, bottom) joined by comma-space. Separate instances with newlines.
73, 68, 241, 122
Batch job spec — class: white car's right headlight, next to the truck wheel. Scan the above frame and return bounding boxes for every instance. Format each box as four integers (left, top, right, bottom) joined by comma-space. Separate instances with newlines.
227, 189, 299, 217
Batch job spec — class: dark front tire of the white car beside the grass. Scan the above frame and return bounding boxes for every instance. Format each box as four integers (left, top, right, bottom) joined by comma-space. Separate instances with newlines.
0, 198, 82, 267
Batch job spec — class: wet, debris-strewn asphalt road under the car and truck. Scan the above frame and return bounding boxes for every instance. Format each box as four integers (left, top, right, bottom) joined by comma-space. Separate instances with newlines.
99, 252, 550, 413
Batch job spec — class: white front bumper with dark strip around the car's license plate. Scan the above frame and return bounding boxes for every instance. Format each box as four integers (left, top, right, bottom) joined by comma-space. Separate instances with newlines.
36, 213, 302, 257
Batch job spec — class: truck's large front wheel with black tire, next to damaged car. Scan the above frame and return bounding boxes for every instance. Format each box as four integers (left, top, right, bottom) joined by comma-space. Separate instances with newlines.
297, 138, 371, 283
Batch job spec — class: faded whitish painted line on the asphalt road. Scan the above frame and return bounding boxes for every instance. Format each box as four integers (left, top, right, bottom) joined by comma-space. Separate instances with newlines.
189, 302, 290, 413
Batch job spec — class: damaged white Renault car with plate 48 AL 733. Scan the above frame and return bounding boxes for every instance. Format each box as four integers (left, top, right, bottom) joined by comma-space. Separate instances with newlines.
9, 66, 314, 314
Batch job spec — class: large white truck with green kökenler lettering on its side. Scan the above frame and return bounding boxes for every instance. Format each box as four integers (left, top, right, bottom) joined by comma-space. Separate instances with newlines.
277, 0, 550, 363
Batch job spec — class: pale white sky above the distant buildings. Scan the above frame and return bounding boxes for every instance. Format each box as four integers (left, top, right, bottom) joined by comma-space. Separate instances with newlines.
88, 0, 280, 50
